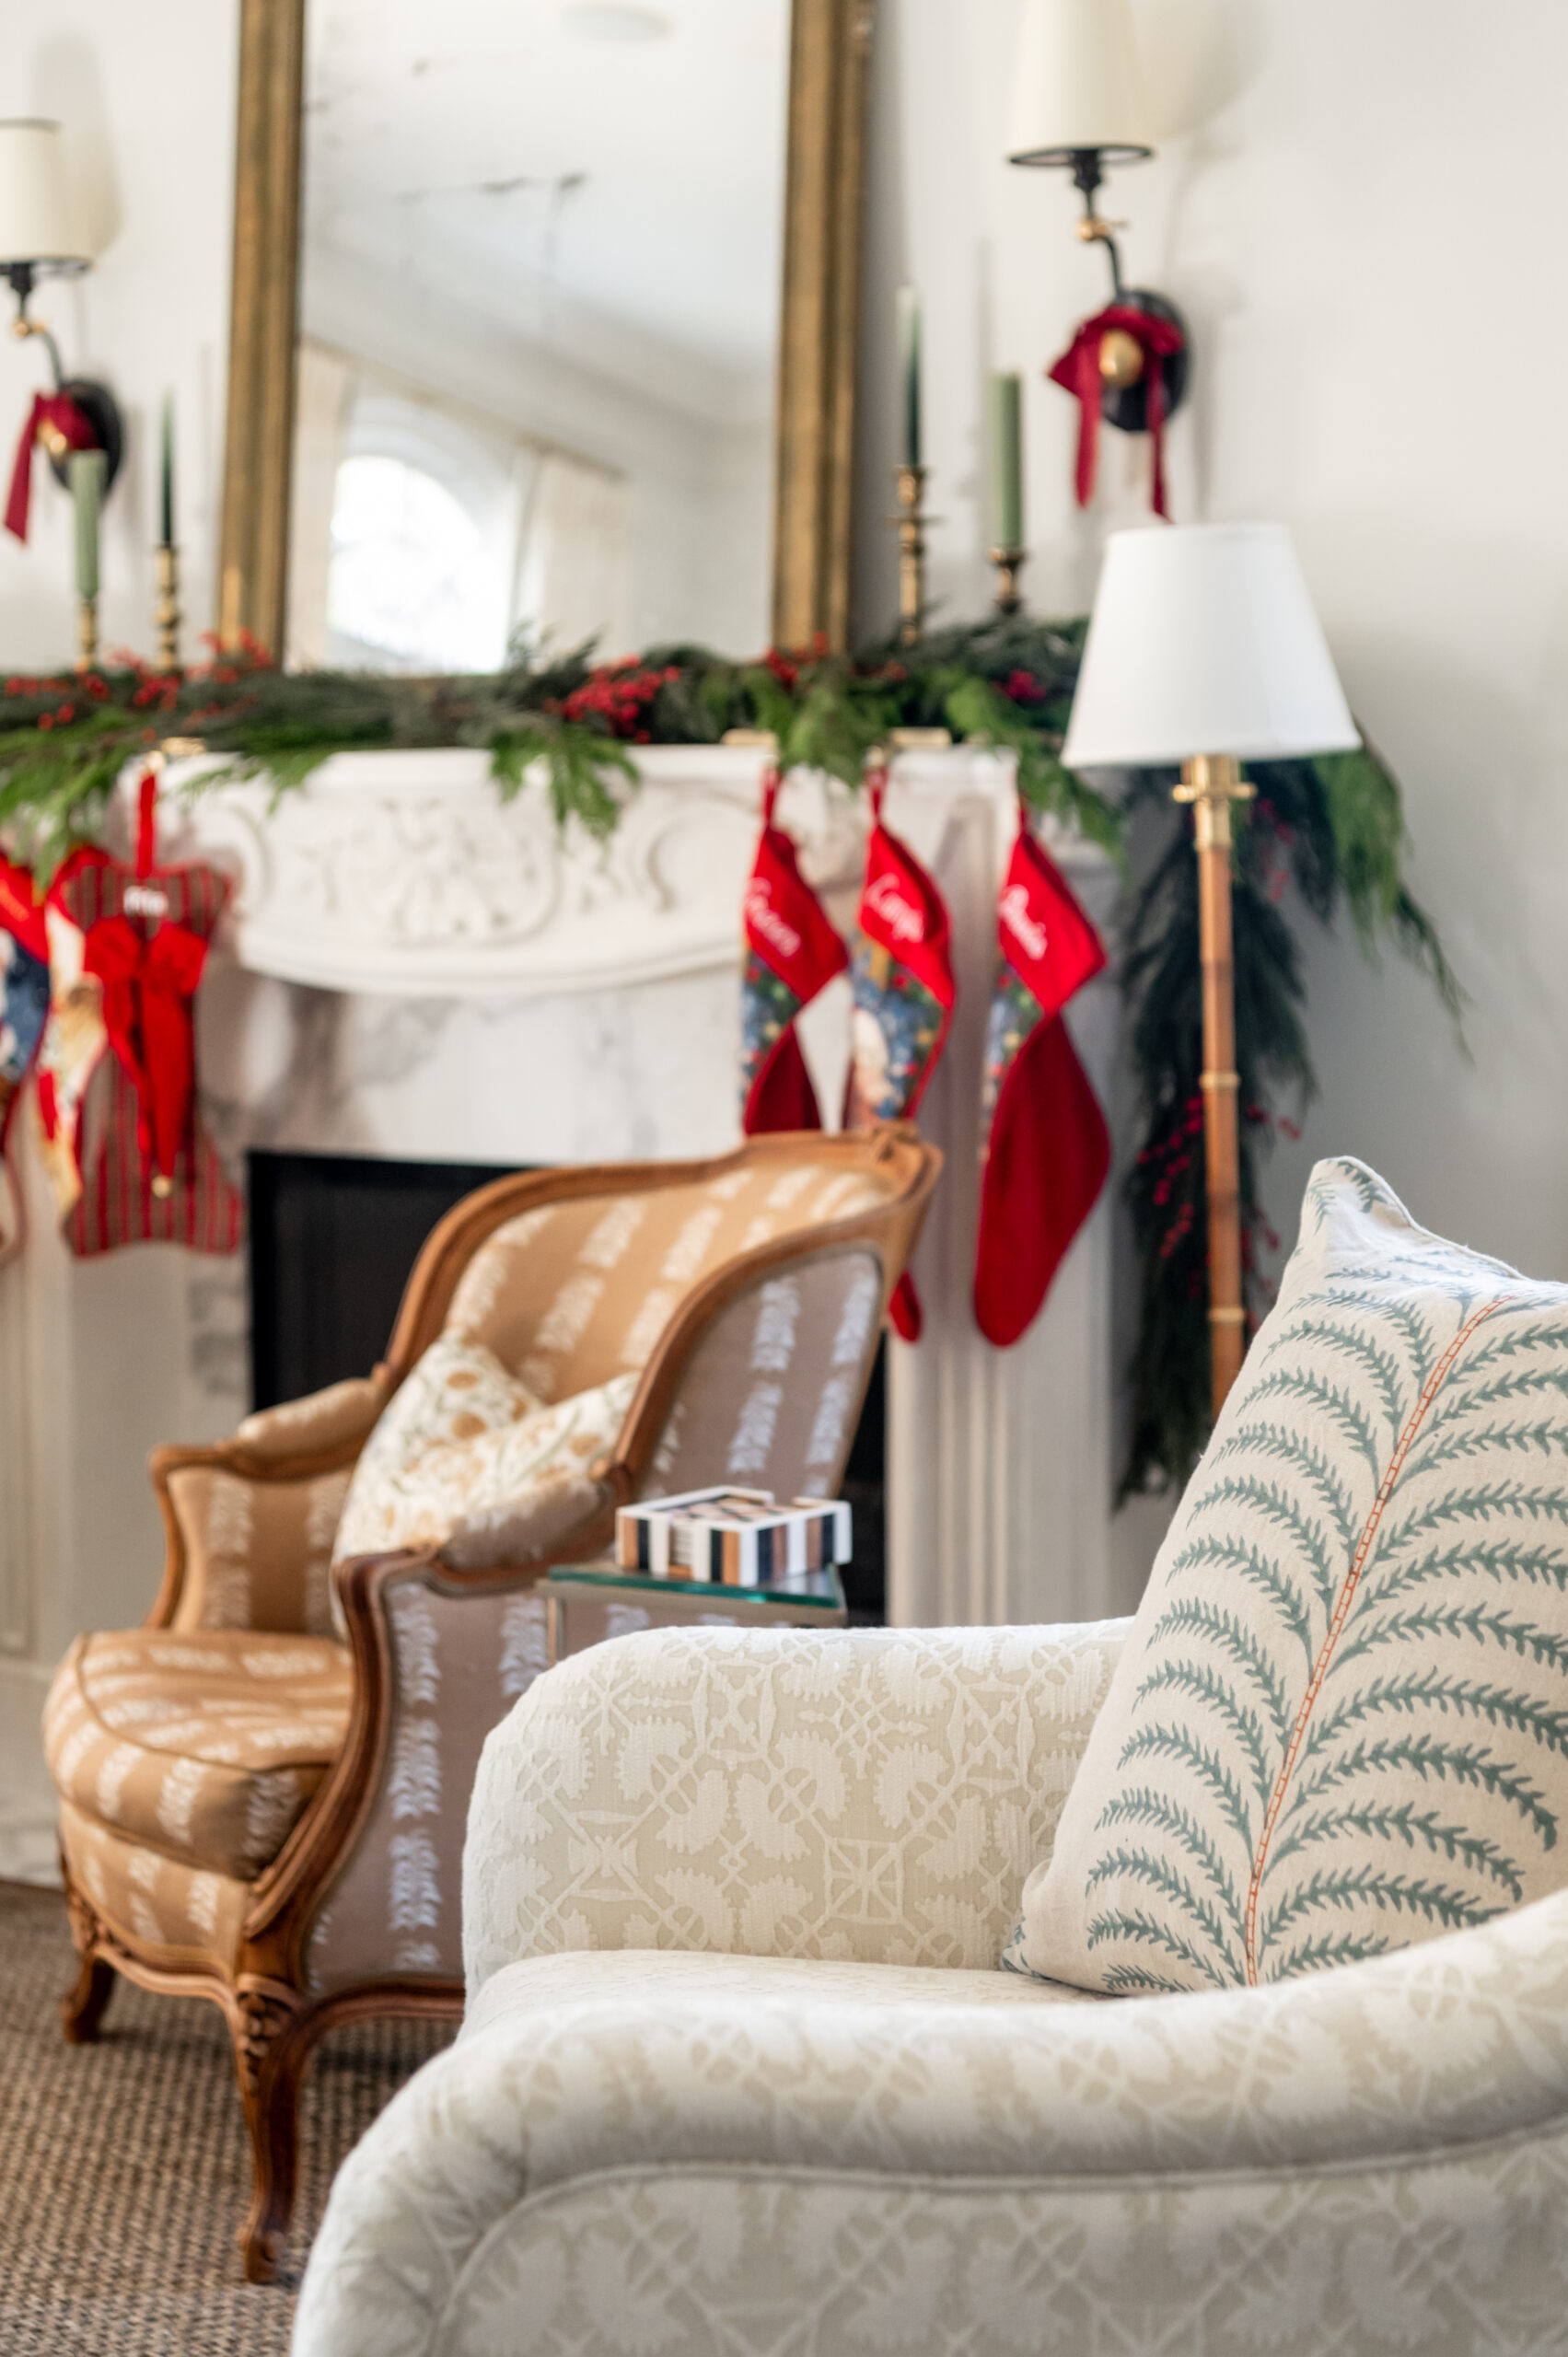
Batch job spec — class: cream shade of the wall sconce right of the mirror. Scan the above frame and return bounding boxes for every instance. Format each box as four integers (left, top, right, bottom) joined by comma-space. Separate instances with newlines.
1007, 0, 1153, 163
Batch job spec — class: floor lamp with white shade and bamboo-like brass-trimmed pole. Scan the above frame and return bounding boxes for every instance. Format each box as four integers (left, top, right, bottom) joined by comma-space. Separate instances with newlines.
1061, 523, 1361, 1414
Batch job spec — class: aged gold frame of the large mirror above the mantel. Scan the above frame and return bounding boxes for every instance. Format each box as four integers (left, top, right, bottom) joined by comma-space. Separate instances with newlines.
217, 0, 875, 653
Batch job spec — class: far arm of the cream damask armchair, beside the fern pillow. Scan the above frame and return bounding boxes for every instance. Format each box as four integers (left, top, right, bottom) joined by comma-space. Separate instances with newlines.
462, 1621, 1127, 1996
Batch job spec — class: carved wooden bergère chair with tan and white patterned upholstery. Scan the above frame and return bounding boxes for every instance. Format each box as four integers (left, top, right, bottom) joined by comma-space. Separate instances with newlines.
45, 1129, 941, 2282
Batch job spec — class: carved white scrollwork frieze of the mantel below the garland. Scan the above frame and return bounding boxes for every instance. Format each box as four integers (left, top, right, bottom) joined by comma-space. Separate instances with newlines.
168, 745, 861, 997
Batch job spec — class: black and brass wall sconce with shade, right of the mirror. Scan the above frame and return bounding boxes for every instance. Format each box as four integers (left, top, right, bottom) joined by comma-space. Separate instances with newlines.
1007, 0, 1189, 434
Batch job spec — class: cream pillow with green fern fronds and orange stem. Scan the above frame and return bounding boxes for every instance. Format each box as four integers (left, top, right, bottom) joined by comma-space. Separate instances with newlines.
1007, 1162, 1568, 1994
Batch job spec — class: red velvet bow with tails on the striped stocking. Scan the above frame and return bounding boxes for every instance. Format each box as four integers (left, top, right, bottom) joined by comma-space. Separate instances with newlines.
83, 917, 207, 1195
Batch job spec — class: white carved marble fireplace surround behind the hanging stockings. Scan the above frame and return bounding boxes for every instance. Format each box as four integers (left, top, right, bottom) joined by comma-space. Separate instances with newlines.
0, 748, 1125, 1874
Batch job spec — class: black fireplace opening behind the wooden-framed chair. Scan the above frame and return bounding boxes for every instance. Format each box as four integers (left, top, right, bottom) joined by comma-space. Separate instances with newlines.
248, 1148, 887, 1624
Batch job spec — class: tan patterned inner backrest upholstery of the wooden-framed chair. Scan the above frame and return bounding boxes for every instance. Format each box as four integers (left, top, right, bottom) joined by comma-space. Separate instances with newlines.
446, 1160, 891, 1400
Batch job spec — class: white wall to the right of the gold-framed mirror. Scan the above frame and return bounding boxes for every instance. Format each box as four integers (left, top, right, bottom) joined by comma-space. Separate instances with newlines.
858, 0, 1568, 1573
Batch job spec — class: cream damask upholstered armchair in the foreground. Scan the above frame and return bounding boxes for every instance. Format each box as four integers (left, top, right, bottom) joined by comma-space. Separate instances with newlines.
295, 1621, 1568, 2357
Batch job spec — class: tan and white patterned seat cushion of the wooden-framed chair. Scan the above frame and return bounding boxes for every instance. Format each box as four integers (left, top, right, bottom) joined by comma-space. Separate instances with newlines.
45, 1629, 352, 1881
